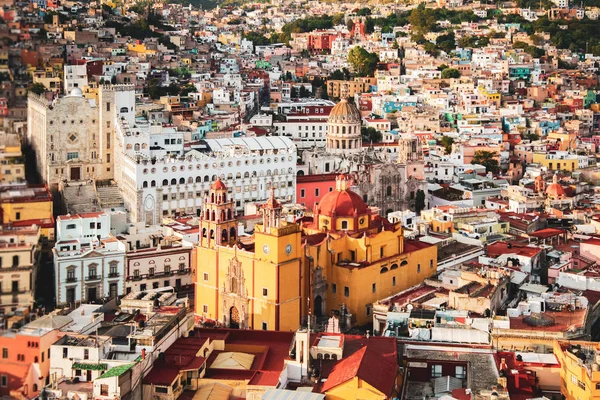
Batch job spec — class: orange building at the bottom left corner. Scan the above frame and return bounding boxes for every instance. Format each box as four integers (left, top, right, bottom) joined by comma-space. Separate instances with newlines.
0, 315, 68, 399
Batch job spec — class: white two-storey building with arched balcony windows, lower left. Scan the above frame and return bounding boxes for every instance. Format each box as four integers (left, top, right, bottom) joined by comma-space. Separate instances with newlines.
53, 212, 125, 304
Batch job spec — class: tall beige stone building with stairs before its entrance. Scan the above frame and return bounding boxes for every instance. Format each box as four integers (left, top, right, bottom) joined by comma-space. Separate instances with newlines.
27, 85, 135, 188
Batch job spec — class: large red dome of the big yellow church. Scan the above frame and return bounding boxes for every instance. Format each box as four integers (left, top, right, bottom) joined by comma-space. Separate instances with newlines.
317, 177, 369, 217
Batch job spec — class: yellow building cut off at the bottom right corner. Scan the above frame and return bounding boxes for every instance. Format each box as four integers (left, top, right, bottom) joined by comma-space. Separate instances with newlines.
554, 340, 600, 400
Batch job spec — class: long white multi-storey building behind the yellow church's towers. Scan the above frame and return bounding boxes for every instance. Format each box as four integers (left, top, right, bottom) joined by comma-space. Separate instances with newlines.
115, 119, 296, 225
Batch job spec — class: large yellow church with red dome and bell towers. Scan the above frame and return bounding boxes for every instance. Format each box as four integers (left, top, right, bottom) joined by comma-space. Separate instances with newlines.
195, 175, 437, 331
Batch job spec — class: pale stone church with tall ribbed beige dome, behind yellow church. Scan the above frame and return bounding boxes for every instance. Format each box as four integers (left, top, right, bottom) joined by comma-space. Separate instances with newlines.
298, 99, 427, 215
